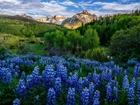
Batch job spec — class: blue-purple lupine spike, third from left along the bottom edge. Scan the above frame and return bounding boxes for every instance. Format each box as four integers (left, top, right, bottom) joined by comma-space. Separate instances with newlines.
67, 88, 75, 105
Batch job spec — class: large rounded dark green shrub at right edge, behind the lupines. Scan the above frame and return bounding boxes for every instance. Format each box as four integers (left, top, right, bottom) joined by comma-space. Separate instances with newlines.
110, 25, 140, 62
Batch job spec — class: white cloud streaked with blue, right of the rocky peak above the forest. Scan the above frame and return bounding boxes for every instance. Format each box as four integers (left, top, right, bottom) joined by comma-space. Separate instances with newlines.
79, 2, 140, 16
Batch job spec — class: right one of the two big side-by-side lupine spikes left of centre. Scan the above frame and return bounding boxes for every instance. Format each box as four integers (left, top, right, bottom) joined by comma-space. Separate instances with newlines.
56, 64, 67, 82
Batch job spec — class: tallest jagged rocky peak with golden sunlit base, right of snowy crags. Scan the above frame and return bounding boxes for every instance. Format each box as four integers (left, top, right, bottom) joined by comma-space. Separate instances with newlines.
62, 10, 97, 29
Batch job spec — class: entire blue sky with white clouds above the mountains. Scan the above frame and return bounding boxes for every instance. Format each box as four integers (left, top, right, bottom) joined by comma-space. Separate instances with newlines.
0, 0, 140, 17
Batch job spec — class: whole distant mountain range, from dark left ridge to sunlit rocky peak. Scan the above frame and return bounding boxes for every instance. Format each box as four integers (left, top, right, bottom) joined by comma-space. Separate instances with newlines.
0, 10, 97, 29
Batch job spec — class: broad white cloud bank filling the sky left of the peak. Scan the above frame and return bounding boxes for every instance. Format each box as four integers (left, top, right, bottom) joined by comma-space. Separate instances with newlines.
0, 0, 76, 17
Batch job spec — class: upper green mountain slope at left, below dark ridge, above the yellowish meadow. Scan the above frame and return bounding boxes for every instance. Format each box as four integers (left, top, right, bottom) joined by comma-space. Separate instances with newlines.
0, 16, 64, 36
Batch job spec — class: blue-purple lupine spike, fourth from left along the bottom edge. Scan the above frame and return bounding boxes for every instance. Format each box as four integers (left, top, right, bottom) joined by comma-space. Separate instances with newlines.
80, 87, 89, 105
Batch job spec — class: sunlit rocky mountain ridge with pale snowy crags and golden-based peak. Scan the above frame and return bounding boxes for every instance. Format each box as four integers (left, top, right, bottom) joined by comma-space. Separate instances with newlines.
35, 10, 97, 29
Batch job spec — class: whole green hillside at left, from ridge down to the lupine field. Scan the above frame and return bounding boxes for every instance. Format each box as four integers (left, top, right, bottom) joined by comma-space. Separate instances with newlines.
0, 16, 66, 54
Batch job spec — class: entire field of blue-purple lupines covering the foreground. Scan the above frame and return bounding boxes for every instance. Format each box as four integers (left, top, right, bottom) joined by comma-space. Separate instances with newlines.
0, 54, 140, 105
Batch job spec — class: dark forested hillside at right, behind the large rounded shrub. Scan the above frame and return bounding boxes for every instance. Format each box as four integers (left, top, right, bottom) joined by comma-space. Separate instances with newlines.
78, 14, 140, 46
